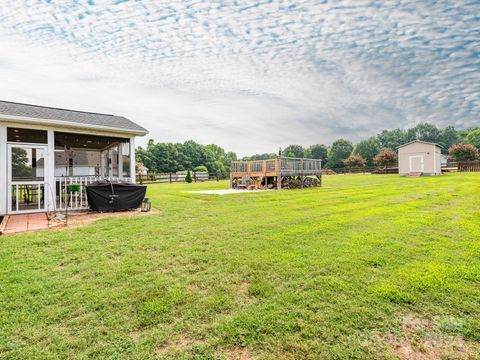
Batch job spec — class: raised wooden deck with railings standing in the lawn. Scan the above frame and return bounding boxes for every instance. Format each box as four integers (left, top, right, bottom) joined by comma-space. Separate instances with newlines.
230, 156, 322, 189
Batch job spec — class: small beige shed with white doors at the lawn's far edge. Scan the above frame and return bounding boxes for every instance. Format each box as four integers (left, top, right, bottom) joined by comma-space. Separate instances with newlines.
398, 140, 442, 176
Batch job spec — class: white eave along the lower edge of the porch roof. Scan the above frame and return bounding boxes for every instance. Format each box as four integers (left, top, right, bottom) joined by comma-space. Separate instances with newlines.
0, 114, 148, 136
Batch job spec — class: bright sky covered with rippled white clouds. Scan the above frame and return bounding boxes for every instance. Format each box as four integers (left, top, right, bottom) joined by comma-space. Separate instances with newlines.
0, 0, 480, 155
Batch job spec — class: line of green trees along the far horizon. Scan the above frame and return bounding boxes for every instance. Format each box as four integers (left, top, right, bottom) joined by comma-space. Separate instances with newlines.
136, 123, 480, 177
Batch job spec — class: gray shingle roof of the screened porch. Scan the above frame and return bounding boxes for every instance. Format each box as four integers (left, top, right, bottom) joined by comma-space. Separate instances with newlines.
0, 100, 148, 134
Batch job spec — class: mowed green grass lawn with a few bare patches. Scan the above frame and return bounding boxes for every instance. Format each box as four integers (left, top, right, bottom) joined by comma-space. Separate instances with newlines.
0, 173, 480, 359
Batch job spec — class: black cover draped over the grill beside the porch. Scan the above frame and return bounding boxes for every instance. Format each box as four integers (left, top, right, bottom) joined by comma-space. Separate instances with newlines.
87, 182, 147, 212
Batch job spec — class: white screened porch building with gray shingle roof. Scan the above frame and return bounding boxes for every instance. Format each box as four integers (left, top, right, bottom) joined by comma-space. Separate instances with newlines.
0, 101, 148, 215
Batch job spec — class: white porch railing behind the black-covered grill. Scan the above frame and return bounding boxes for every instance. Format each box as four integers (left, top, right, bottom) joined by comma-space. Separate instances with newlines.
55, 176, 131, 210
